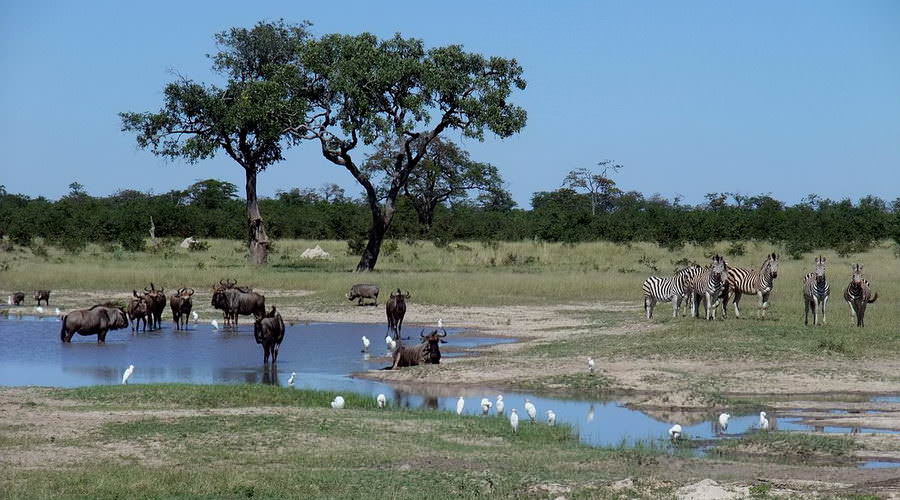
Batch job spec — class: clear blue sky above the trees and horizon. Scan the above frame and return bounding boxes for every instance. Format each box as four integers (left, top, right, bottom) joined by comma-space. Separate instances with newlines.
0, 0, 900, 206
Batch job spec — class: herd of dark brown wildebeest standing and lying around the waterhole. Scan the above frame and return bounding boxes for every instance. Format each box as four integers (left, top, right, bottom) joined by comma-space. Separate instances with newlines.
9, 279, 447, 369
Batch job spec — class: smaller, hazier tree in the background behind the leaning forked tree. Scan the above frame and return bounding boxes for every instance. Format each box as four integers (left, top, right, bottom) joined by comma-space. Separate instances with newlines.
365, 137, 503, 231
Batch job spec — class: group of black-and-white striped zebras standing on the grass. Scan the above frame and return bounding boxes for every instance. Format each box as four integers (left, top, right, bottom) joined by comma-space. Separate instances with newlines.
642, 252, 878, 327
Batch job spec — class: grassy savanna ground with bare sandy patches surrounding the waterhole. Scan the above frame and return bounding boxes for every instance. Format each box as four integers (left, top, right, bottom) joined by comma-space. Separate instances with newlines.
0, 240, 900, 498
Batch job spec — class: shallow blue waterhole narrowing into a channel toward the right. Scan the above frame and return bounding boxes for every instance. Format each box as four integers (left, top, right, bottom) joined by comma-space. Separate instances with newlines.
0, 317, 900, 467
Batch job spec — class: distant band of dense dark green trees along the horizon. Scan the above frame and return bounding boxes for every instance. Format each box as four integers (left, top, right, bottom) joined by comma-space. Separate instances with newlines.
0, 180, 900, 255
